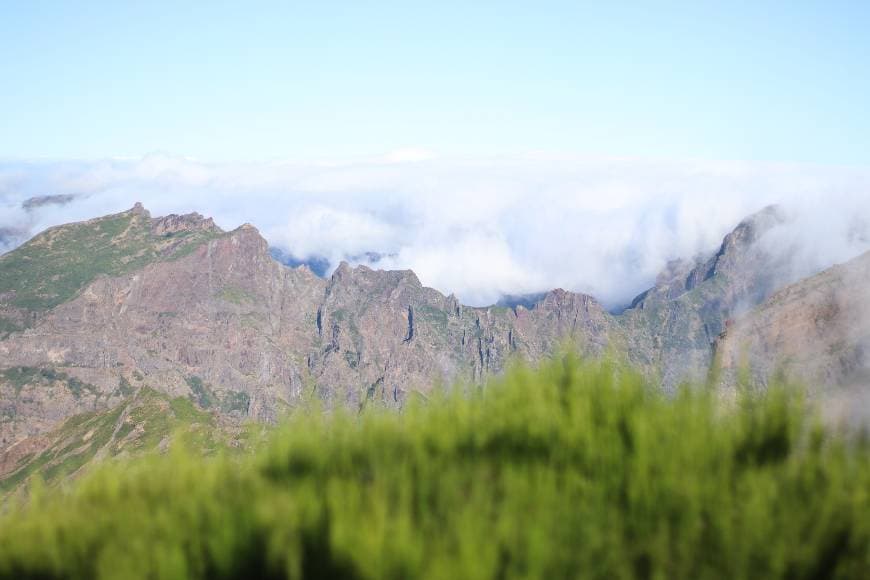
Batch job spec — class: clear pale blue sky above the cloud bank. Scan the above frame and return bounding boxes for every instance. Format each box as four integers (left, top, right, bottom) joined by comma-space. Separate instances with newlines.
0, 1, 870, 166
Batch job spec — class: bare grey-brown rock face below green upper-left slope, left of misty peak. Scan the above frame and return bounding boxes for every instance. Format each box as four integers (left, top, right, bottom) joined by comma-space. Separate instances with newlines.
0, 206, 614, 445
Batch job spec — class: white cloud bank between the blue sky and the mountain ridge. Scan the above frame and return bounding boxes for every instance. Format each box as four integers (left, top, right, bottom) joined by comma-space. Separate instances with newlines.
0, 150, 870, 307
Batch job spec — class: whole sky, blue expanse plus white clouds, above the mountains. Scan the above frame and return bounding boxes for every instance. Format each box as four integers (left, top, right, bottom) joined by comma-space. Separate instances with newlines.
0, 0, 870, 308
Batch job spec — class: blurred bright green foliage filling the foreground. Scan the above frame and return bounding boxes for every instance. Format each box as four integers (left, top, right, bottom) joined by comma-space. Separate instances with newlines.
0, 357, 870, 579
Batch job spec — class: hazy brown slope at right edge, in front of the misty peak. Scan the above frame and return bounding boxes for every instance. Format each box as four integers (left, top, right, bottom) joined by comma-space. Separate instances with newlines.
716, 253, 870, 421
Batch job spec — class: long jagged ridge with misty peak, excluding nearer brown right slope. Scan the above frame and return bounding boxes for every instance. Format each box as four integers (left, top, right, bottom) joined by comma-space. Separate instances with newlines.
0, 204, 868, 488
